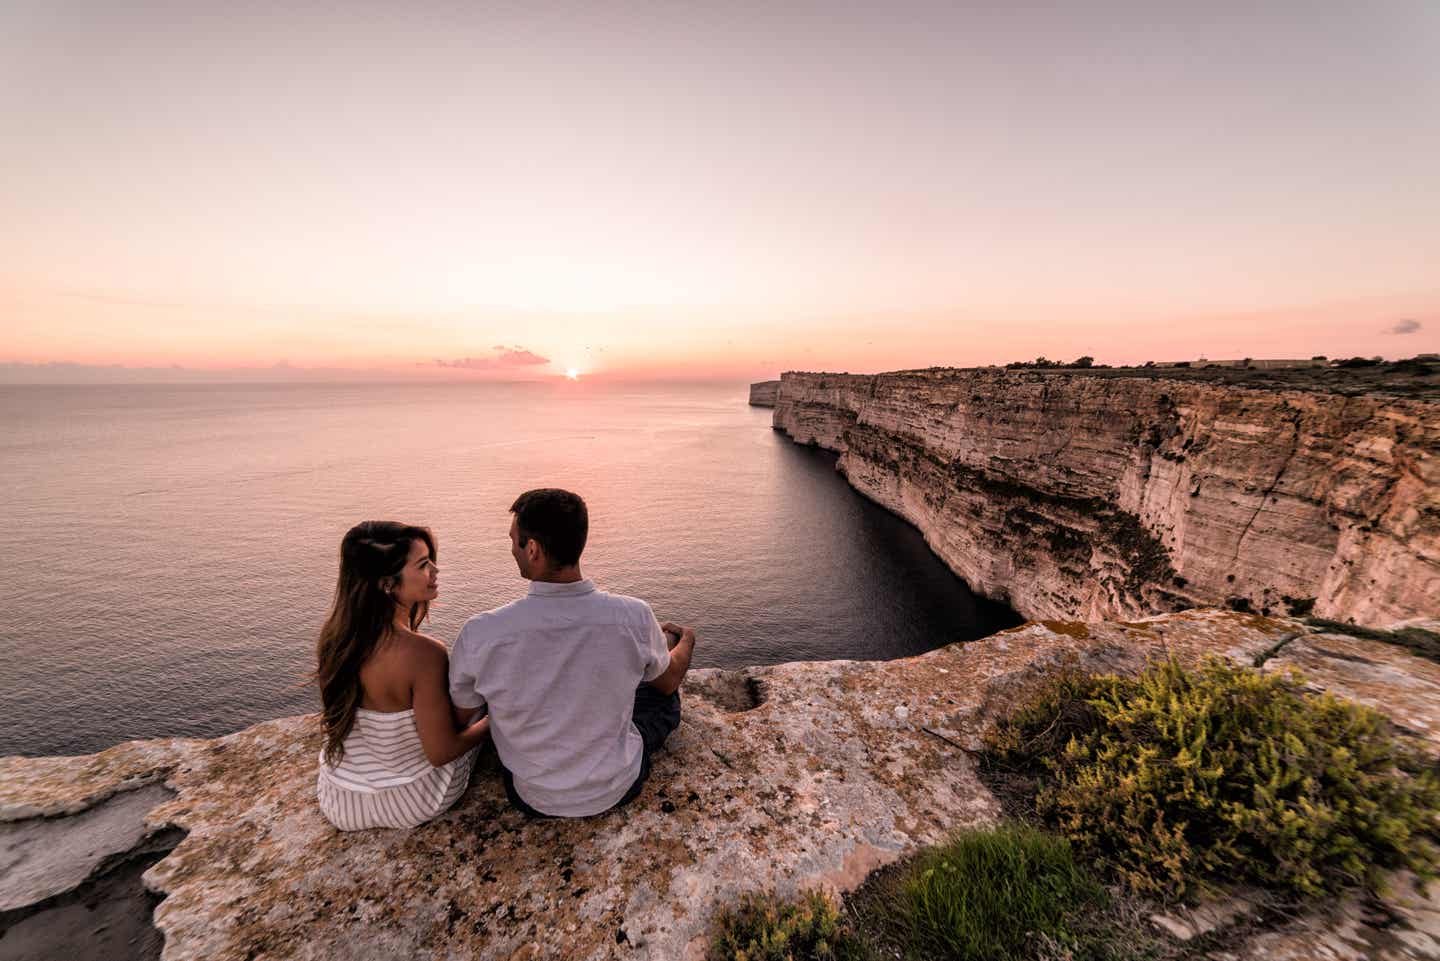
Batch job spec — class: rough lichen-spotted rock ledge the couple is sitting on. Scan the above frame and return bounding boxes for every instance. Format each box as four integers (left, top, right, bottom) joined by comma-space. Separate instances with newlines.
0, 609, 1440, 961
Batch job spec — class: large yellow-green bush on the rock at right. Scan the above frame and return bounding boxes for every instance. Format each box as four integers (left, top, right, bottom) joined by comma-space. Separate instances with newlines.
989, 658, 1440, 898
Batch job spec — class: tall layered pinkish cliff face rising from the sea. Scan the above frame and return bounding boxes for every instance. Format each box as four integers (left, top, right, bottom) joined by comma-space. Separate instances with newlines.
775, 370, 1440, 624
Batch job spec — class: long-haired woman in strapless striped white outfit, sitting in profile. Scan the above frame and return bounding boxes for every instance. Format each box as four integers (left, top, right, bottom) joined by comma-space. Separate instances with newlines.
315, 520, 490, 831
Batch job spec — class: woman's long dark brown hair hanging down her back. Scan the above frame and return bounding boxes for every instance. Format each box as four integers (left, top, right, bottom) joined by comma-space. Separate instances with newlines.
315, 520, 438, 766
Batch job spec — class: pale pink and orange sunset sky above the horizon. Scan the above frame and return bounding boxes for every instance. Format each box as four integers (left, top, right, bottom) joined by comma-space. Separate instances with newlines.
0, 0, 1440, 380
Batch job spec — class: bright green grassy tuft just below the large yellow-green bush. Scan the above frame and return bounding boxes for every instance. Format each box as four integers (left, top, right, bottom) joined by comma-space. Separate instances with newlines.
883, 824, 1104, 961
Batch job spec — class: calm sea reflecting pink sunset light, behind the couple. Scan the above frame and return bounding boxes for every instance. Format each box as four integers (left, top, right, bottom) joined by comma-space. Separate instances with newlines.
0, 383, 1012, 755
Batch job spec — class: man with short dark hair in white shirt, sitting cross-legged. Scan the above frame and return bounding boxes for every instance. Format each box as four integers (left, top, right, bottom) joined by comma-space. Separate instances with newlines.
449, 488, 696, 817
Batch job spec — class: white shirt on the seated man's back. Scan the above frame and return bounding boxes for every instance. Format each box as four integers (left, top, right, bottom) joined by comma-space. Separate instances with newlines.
451, 581, 670, 817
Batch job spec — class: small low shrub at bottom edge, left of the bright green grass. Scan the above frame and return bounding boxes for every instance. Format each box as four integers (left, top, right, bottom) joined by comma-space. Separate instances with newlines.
706, 890, 870, 961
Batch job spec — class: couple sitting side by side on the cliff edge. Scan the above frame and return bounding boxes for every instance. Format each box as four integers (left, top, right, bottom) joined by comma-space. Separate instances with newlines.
317, 488, 696, 830
